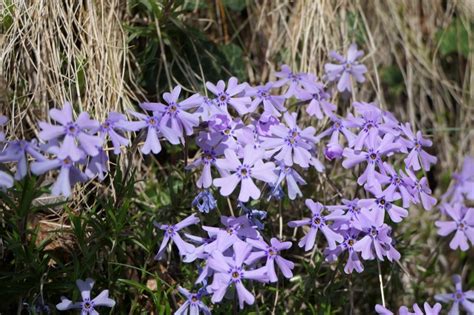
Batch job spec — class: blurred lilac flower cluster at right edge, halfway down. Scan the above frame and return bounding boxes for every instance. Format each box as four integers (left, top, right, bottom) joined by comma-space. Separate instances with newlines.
435, 156, 474, 251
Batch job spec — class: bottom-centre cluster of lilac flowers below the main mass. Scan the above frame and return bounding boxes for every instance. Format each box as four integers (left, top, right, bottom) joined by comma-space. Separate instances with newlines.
155, 211, 294, 313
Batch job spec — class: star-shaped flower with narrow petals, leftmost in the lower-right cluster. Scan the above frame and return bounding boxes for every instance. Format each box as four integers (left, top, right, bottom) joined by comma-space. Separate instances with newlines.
288, 199, 344, 251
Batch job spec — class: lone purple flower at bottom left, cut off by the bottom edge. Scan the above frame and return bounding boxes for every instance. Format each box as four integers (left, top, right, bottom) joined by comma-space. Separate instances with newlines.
56, 278, 115, 315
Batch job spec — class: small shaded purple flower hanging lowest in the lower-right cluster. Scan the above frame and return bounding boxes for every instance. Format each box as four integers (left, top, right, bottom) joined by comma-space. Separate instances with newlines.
324, 229, 364, 274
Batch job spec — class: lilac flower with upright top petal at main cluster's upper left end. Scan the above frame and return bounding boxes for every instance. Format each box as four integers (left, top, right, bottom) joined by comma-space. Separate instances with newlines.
140, 85, 202, 142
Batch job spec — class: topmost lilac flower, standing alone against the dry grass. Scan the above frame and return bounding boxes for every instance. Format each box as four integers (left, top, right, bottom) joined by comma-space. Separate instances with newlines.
324, 44, 367, 92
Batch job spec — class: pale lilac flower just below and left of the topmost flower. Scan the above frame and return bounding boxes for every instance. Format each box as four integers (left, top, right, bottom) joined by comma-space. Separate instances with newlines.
296, 82, 336, 119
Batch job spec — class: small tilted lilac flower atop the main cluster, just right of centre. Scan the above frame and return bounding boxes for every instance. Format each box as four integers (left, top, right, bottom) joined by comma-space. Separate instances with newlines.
246, 82, 286, 117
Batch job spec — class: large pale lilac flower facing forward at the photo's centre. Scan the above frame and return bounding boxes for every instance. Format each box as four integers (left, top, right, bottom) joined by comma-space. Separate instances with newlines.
214, 145, 276, 202
